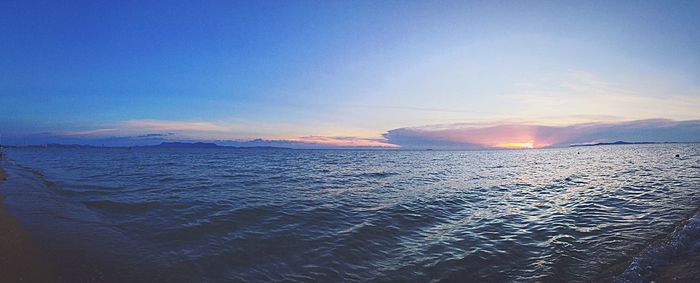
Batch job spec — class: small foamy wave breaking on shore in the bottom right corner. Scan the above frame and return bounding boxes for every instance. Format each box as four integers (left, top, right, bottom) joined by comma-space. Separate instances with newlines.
613, 211, 700, 283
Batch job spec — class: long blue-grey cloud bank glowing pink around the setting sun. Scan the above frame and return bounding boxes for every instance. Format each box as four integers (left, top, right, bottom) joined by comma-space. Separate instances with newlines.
384, 119, 700, 149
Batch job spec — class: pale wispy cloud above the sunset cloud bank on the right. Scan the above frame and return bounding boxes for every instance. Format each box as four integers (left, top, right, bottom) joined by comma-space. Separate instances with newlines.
502, 71, 700, 123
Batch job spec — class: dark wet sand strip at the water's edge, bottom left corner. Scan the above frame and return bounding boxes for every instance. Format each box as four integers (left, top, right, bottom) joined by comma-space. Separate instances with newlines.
0, 164, 62, 282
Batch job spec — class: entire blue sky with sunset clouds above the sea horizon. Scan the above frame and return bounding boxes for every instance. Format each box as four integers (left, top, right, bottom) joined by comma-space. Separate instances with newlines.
0, 1, 700, 148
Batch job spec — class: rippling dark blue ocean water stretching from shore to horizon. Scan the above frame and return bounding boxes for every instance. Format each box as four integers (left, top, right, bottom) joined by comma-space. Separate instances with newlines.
0, 144, 700, 282
